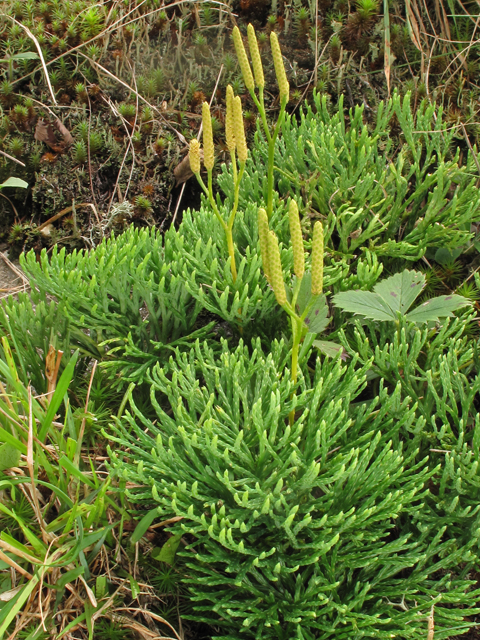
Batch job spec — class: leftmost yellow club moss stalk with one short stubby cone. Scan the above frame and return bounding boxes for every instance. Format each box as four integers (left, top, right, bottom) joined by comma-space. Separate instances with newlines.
188, 94, 248, 282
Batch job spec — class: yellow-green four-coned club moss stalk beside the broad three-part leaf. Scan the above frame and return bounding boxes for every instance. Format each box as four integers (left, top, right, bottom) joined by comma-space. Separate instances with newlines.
258, 200, 323, 424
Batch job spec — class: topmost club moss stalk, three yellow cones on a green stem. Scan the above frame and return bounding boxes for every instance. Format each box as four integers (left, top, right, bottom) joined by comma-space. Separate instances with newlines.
232, 24, 290, 218
